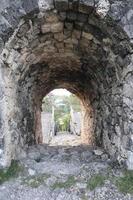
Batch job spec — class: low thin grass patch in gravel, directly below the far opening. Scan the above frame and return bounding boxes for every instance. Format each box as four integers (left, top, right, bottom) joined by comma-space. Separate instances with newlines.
52, 176, 76, 190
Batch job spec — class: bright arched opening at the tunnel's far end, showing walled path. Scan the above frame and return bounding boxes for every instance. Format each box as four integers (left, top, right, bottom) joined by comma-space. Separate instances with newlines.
41, 89, 82, 146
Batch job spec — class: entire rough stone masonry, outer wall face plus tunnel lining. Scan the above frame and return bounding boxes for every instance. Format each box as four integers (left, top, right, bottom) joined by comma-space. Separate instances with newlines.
0, 0, 133, 169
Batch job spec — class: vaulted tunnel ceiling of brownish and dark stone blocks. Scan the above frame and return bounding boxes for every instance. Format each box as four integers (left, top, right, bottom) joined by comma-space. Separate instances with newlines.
2, 5, 132, 101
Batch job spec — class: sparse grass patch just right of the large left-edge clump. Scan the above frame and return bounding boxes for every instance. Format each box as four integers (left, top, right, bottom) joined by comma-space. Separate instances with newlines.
23, 174, 50, 188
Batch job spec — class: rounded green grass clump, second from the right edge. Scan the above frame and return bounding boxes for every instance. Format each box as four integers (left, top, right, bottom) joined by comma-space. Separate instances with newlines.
87, 174, 107, 190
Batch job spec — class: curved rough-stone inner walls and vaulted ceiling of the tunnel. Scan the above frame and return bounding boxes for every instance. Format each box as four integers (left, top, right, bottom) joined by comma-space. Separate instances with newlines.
1, 1, 132, 169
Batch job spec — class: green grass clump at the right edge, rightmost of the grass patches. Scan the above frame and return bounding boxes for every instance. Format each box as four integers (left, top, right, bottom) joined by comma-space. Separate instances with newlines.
115, 170, 133, 194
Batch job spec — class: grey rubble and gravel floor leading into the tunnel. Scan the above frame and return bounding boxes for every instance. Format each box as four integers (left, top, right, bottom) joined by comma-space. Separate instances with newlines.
0, 136, 133, 200
